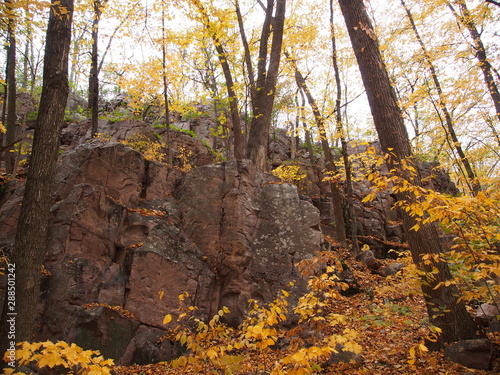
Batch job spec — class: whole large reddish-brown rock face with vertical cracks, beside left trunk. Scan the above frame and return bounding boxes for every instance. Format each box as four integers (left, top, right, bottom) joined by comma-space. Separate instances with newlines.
0, 141, 321, 364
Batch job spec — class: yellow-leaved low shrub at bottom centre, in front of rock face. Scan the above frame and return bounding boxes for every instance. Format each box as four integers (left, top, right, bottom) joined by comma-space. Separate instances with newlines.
169, 255, 361, 374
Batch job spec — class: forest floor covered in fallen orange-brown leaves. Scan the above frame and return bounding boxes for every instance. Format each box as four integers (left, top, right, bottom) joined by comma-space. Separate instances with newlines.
114, 253, 500, 375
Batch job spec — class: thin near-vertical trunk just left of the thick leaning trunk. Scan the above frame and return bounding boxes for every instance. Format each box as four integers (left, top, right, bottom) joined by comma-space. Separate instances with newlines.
330, 0, 359, 255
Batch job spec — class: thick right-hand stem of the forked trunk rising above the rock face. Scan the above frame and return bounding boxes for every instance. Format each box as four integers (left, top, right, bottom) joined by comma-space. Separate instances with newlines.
246, 0, 286, 171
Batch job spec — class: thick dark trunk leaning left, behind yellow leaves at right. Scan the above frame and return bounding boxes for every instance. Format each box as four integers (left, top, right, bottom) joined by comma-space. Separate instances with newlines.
339, 0, 477, 347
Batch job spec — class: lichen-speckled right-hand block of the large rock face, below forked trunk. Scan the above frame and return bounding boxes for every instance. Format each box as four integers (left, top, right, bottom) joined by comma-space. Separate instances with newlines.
175, 161, 321, 325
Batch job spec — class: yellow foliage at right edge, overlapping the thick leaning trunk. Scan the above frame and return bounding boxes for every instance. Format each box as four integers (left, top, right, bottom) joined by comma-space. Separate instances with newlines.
363, 153, 500, 312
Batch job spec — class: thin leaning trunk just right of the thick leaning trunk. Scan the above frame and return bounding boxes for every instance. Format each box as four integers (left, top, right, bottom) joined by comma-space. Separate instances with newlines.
400, 0, 481, 195
